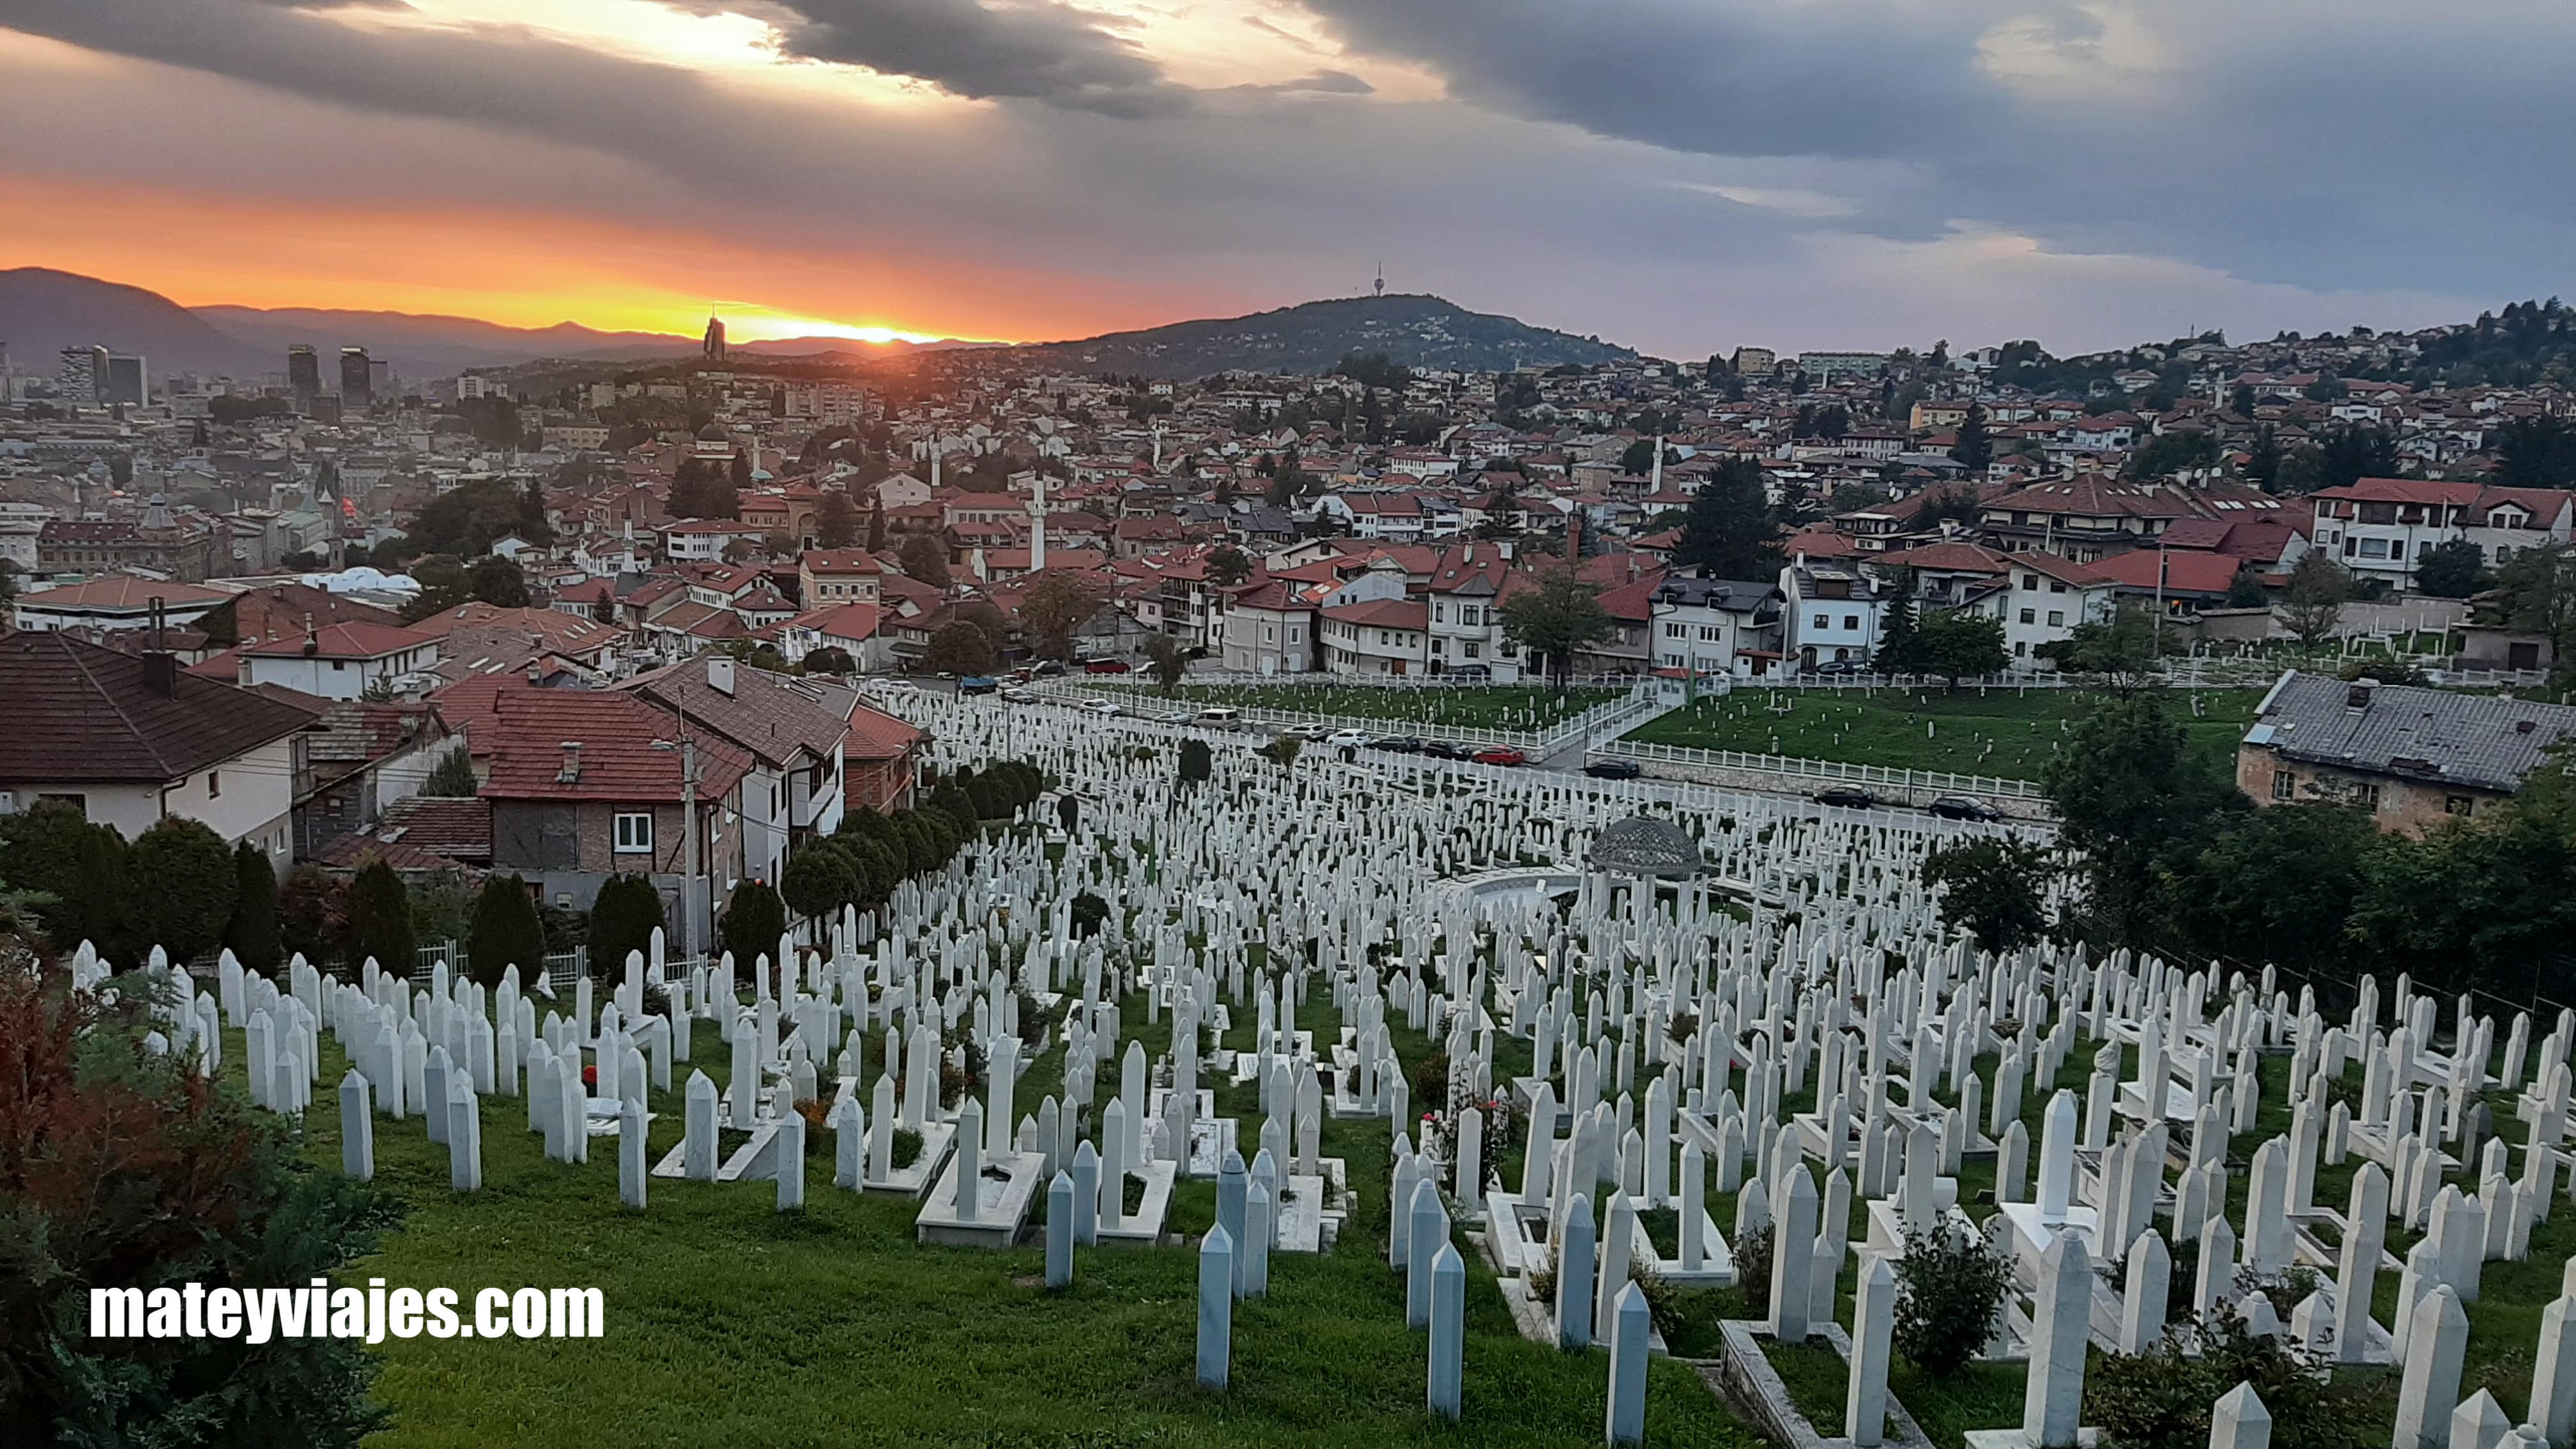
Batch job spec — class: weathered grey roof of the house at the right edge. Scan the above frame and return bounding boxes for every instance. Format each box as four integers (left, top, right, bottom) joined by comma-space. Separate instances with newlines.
2246, 673, 2576, 792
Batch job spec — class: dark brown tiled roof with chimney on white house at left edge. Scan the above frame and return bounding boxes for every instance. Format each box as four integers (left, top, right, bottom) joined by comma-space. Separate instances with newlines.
0, 632, 319, 784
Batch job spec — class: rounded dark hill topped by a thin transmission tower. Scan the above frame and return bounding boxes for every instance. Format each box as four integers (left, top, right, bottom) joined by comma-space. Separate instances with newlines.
974, 294, 1636, 381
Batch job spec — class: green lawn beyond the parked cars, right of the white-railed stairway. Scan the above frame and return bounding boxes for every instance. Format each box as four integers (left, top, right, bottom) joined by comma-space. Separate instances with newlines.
1628, 686, 2262, 779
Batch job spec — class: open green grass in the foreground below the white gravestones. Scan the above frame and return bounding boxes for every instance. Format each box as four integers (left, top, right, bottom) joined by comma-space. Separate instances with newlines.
242, 998, 1754, 1449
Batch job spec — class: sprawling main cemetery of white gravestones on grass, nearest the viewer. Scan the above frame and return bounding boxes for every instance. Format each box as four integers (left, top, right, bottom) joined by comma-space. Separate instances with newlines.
20, 691, 2576, 1449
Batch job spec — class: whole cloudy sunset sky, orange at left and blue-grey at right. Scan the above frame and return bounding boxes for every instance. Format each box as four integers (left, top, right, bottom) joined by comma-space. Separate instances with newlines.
0, 0, 2576, 356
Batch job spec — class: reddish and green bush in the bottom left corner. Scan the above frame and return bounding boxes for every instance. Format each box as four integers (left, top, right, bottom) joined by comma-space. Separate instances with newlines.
0, 969, 402, 1449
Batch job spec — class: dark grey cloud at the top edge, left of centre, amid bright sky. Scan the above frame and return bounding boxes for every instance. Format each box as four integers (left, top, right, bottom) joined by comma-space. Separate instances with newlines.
752, 0, 1190, 116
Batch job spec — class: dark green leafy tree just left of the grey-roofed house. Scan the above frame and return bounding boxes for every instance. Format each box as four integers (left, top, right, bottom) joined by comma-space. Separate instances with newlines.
2040, 691, 2251, 941
